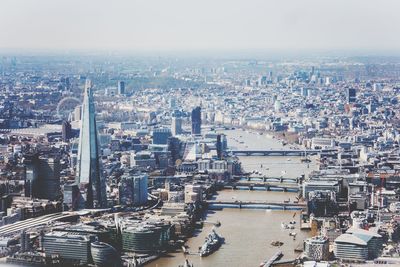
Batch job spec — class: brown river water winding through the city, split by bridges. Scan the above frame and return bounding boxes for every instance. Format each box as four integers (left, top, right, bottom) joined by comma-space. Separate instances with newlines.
146, 130, 317, 267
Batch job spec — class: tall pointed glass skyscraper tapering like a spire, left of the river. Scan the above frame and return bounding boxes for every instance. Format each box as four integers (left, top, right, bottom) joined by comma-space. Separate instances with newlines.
76, 80, 107, 208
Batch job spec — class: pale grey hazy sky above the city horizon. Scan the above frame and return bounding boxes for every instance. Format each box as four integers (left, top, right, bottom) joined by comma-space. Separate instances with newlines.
0, 0, 400, 51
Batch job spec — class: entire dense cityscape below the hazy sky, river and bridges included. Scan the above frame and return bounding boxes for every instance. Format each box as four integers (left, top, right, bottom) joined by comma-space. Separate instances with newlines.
0, 55, 400, 266
